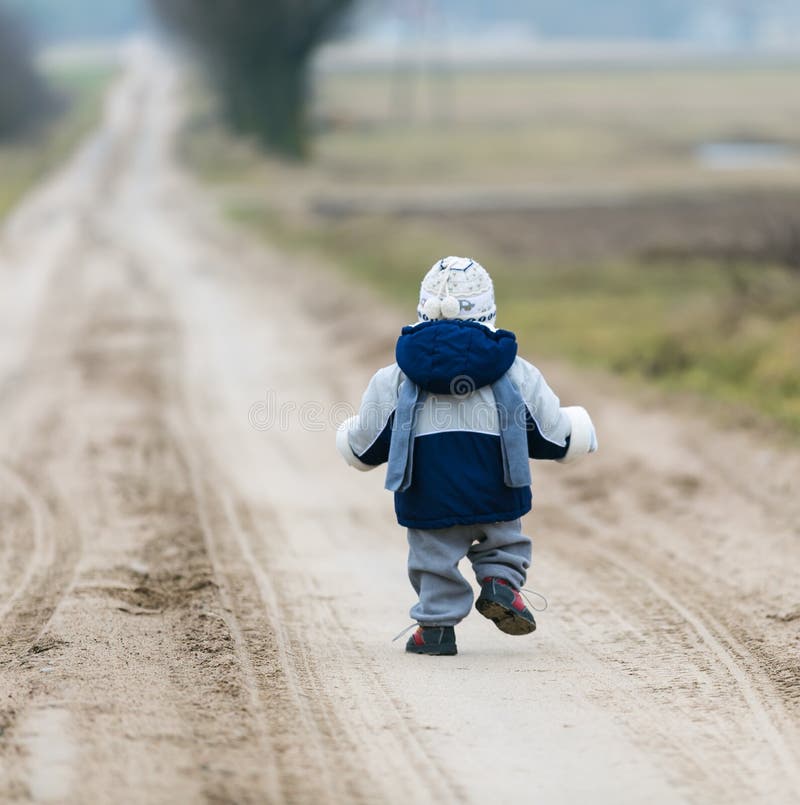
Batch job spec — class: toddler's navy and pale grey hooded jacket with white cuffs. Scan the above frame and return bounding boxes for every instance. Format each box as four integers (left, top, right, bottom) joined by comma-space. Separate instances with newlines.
337, 320, 597, 529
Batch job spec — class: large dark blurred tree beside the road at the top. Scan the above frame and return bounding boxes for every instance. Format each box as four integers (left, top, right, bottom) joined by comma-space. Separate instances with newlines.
150, 0, 353, 158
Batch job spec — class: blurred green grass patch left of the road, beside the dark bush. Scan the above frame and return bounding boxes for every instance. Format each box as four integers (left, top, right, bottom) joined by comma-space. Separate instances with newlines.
0, 64, 117, 219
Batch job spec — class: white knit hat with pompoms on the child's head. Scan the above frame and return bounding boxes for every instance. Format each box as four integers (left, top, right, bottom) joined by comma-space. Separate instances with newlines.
417, 257, 497, 327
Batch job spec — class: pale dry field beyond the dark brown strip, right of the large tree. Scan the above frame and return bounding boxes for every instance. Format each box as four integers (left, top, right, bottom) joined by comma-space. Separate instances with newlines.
315, 66, 800, 189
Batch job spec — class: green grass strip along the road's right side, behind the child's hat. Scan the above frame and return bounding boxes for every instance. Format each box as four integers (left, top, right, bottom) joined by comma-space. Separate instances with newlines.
229, 205, 800, 433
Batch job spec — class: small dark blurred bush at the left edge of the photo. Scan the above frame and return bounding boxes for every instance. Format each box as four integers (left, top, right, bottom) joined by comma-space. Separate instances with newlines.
0, 7, 56, 140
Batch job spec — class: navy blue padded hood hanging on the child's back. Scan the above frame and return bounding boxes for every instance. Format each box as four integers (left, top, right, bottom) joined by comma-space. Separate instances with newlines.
395, 319, 517, 394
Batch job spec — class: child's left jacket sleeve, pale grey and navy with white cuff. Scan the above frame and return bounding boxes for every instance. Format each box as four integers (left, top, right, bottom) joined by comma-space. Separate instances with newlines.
336, 364, 402, 472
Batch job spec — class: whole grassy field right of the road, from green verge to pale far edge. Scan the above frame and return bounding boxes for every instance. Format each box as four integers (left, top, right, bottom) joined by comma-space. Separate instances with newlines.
183, 61, 800, 430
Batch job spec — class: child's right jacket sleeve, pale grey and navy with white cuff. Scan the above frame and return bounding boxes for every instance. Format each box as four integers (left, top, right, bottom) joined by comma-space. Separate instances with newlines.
509, 358, 597, 463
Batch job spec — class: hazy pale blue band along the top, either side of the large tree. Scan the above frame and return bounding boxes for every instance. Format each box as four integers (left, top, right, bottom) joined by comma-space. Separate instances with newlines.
6, 0, 800, 45
